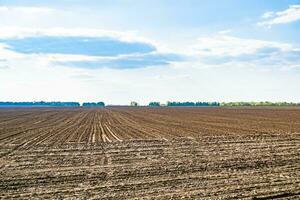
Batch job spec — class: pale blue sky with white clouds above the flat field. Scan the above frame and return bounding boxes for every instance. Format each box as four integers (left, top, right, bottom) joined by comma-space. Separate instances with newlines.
0, 0, 300, 105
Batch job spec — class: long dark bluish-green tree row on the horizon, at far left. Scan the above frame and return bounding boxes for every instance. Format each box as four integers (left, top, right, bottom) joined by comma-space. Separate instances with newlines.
0, 101, 80, 107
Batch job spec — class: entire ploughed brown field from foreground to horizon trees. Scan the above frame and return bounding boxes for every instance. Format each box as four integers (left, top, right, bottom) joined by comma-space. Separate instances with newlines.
0, 107, 300, 199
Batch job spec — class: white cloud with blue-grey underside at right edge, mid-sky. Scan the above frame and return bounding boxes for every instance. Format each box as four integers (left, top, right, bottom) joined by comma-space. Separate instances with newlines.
190, 34, 300, 71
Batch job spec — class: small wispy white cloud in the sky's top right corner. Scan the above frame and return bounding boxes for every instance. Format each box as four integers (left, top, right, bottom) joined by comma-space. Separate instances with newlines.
257, 5, 300, 27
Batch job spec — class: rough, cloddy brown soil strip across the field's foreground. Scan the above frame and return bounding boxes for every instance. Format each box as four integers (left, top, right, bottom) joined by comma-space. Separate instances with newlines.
0, 136, 300, 199
